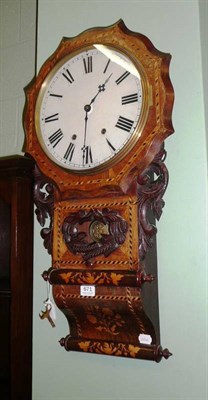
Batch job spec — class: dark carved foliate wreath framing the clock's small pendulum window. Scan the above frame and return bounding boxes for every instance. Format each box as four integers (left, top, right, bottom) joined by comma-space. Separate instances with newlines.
62, 208, 128, 265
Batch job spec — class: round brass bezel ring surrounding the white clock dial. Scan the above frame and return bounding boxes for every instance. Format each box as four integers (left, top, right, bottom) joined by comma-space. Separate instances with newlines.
35, 43, 152, 175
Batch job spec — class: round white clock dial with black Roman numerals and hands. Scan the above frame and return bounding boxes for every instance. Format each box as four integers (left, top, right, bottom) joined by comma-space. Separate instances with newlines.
36, 45, 143, 172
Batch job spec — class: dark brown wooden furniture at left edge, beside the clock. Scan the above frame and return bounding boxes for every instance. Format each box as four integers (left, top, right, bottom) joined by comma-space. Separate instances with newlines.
0, 156, 34, 400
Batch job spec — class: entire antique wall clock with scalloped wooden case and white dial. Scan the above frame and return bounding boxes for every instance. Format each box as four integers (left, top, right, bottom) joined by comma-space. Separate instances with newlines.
24, 20, 174, 361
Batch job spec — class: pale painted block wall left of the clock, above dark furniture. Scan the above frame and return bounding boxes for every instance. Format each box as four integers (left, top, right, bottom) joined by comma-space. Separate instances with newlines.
0, 0, 36, 156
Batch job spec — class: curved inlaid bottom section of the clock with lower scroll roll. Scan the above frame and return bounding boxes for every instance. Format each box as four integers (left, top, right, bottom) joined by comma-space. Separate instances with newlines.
53, 285, 170, 362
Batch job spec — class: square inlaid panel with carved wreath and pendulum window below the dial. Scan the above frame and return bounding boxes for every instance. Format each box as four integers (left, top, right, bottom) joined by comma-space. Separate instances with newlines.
53, 196, 138, 270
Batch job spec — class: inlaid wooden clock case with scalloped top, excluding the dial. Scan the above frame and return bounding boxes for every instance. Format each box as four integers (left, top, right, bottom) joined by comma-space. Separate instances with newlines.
24, 21, 173, 361
